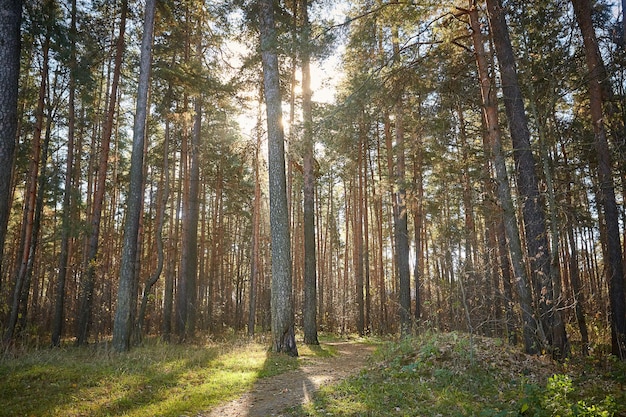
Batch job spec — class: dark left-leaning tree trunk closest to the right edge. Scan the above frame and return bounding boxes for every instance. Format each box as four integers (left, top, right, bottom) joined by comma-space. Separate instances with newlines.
572, 0, 626, 359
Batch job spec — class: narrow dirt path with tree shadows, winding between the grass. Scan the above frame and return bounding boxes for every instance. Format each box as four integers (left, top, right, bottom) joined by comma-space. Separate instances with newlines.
198, 342, 374, 417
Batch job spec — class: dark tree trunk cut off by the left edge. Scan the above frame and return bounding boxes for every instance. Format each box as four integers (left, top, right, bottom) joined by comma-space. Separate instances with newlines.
0, 0, 22, 290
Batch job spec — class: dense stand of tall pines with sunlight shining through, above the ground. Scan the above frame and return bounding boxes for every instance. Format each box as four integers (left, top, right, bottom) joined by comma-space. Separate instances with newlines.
0, 0, 626, 359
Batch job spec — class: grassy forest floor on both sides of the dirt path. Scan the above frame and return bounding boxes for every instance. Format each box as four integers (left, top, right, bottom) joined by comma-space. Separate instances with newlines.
0, 333, 626, 417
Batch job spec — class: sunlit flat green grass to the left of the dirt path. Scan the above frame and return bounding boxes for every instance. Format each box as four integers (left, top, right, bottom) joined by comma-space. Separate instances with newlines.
0, 341, 298, 416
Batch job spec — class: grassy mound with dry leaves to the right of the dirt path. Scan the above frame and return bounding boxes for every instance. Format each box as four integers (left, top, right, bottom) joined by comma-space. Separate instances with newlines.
290, 333, 626, 417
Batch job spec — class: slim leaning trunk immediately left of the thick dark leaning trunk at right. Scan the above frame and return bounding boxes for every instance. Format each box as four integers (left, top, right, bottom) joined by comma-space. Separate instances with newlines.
469, 0, 540, 353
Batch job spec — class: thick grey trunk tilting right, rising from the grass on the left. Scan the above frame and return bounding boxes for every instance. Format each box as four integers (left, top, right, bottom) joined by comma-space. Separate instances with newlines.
113, 0, 156, 352
